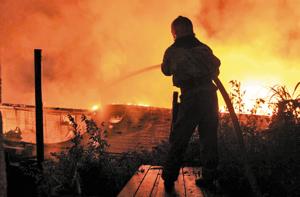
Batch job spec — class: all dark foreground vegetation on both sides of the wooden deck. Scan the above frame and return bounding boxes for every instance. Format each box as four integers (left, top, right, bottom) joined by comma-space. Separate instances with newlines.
4, 82, 300, 197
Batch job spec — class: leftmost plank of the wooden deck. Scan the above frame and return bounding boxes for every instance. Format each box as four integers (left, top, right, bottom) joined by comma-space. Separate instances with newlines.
118, 165, 151, 197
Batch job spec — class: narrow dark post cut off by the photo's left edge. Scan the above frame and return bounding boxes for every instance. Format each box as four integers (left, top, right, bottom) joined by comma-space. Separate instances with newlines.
0, 111, 7, 197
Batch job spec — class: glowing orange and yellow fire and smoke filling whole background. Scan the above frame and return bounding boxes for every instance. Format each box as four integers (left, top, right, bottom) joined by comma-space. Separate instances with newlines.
0, 0, 300, 113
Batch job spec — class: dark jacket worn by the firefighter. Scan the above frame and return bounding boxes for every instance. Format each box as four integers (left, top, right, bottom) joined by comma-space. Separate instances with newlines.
161, 35, 221, 89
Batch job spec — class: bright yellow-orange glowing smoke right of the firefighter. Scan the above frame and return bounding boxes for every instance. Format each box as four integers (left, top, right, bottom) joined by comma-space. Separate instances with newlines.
197, 0, 300, 89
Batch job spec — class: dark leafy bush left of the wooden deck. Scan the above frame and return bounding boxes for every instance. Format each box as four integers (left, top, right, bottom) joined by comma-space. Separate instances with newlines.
34, 116, 146, 196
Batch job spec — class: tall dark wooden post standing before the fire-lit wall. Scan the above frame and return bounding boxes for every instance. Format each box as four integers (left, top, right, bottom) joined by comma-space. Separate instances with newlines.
34, 49, 44, 164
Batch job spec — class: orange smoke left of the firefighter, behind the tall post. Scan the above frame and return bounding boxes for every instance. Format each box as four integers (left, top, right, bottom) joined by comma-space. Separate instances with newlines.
0, 0, 202, 108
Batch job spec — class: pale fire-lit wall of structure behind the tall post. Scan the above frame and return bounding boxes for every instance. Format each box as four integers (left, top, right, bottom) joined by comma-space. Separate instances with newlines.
0, 104, 92, 158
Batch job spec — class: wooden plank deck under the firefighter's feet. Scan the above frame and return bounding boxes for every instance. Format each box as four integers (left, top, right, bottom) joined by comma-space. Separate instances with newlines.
118, 165, 211, 197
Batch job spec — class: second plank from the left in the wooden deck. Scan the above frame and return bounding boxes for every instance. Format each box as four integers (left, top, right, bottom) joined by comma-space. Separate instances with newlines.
135, 167, 160, 197
